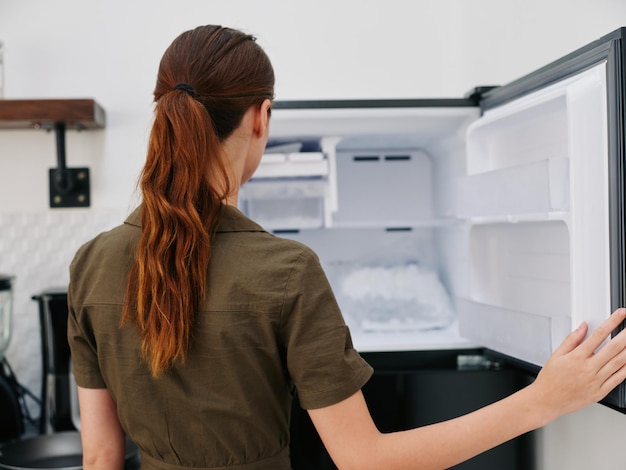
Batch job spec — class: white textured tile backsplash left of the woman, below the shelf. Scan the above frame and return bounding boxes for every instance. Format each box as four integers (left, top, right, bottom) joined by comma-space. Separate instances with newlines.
0, 209, 128, 414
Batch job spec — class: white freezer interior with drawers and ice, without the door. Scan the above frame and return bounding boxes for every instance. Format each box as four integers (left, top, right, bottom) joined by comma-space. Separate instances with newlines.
240, 107, 478, 351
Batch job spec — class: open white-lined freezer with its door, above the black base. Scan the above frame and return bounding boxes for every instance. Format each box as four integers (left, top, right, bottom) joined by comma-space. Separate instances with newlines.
239, 28, 626, 409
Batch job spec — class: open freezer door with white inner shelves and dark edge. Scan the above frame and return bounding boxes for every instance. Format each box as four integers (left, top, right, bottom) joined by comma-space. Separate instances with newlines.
457, 29, 626, 408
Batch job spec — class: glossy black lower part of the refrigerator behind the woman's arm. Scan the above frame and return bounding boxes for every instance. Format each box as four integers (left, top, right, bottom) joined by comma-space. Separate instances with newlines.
291, 350, 535, 470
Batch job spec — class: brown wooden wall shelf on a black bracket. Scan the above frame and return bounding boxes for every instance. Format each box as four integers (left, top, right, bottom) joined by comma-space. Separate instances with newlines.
0, 99, 105, 130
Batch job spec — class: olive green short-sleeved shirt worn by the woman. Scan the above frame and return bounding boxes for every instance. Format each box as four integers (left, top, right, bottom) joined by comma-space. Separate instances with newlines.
68, 207, 372, 470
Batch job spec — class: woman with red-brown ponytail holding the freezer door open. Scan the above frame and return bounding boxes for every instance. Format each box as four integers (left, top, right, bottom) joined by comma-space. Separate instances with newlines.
68, 26, 626, 470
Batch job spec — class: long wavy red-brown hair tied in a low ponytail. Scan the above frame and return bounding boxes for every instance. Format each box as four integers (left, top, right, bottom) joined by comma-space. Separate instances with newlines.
122, 25, 274, 377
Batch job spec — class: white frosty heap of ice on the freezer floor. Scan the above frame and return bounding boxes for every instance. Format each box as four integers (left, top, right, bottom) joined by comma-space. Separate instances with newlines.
337, 264, 455, 331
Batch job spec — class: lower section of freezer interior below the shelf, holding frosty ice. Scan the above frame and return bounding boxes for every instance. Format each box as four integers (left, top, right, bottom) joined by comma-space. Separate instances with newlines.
281, 227, 458, 350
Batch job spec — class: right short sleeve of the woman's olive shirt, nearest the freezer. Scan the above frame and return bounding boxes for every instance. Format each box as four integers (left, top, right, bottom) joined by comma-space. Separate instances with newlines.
281, 249, 373, 409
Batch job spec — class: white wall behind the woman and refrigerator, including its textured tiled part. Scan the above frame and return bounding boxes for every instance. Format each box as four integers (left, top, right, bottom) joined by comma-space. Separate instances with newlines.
0, 0, 626, 470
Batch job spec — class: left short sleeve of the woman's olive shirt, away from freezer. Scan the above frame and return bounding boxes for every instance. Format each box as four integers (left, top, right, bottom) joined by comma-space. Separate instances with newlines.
67, 248, 106, 388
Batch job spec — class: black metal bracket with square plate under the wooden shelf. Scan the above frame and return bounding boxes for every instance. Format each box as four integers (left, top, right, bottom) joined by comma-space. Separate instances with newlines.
49, 122, 91, 208
